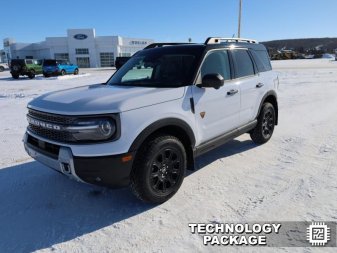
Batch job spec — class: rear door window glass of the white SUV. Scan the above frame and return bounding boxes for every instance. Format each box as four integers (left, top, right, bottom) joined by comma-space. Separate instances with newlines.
232, 50, 255, 78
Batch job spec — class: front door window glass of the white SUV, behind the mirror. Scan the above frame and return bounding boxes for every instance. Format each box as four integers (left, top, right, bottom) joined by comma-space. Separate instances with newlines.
201, 50, 231, 80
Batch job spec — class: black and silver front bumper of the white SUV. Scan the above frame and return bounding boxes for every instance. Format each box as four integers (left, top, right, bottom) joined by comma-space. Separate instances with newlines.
23, 132, 134, 187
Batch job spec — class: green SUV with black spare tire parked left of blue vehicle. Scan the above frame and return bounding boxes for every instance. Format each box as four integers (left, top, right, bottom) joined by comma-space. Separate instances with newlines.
10, 59, 42, 79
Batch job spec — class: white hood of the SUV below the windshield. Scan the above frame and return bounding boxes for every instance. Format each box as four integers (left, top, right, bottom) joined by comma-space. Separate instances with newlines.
28, 84, 185, 115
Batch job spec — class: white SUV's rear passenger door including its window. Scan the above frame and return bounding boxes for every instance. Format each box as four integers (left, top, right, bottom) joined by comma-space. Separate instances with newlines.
231, 49, 265, 125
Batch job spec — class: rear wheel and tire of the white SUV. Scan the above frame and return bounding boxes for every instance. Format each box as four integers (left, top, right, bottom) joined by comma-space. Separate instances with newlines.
250, 103, 276, 144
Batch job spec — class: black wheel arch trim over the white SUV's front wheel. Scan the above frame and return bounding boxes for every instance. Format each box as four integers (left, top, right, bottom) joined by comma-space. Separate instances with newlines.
129, 118, 195, 169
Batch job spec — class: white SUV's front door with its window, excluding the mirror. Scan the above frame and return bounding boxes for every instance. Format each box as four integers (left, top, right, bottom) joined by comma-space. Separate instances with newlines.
192, 49, 240, 142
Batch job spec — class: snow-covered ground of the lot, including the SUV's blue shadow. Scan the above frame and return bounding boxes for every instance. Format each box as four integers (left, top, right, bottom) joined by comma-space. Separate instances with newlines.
0, 59, 337, 252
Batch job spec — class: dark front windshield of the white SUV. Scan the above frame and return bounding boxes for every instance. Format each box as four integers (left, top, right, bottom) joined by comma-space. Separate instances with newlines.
108, 46, 203, 88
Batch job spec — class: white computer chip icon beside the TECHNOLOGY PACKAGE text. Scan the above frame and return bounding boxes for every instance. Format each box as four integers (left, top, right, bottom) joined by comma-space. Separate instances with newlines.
307, 222, 330, 246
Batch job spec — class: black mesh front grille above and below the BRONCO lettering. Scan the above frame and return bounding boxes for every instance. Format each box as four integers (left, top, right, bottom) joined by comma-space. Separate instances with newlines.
28, 109, 76, 143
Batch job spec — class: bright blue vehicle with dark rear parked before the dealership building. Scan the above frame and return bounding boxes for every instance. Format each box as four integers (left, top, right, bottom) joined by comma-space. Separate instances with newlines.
42, 59, 79, 77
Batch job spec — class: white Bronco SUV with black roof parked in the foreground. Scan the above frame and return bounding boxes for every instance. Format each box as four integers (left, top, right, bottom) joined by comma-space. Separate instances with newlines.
24, 38, 278, 203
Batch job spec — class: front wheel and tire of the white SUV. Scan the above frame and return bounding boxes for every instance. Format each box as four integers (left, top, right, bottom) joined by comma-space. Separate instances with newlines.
131, 136, 187, 204
